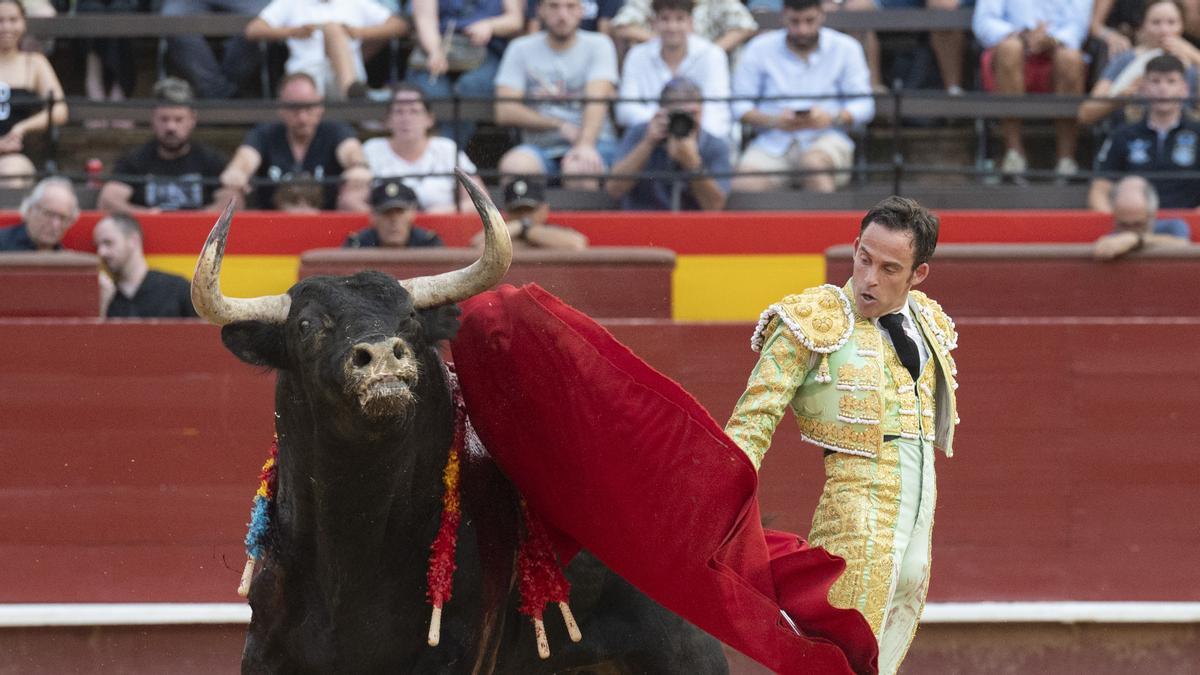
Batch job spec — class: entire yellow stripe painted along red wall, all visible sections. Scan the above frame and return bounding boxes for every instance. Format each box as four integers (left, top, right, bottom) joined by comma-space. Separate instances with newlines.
146, 253, 824, 321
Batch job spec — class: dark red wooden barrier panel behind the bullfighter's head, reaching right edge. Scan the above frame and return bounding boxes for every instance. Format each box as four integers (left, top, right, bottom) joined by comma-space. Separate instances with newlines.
826, 244, 1200, 318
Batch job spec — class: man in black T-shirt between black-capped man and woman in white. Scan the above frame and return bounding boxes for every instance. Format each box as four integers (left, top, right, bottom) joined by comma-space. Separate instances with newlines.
221, 72, 371, 211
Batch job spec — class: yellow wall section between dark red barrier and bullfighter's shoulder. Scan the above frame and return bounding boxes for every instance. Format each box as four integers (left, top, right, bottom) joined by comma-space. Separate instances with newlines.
673, 253, 824, 321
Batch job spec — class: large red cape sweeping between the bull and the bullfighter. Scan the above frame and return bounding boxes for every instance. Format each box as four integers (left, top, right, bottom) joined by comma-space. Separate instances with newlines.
452, 285, 878, 674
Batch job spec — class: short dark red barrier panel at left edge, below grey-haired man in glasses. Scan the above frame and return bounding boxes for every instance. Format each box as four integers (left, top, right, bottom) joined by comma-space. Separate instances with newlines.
0, 251, 100, 317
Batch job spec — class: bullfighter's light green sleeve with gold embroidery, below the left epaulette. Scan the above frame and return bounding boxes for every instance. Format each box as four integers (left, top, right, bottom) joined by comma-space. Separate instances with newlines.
725, 318, 810, 470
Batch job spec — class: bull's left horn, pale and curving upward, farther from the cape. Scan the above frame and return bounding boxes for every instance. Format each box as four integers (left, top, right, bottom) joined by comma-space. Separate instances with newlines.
192, 199, 292, 325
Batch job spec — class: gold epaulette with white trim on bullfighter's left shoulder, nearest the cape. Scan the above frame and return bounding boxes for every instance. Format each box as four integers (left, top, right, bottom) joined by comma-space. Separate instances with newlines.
750, 283, 854, 354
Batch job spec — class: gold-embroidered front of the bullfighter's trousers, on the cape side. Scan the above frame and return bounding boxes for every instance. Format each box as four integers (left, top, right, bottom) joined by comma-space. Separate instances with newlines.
809, 443, 900, 635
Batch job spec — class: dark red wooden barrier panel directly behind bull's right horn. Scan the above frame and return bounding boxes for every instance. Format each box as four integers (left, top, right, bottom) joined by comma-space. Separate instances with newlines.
300, 247, 674, 318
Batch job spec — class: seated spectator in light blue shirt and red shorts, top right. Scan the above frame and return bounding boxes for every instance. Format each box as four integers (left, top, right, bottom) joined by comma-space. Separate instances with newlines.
972, 0, 1092, 178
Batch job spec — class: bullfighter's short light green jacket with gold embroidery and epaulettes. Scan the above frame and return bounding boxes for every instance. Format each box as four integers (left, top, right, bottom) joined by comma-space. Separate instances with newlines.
725, 283, 958, 466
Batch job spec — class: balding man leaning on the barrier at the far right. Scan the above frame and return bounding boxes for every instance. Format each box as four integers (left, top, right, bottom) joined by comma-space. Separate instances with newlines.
1092, 175, 1192, 261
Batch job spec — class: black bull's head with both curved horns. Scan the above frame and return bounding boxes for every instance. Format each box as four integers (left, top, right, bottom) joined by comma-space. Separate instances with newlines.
192, 172, 512, 422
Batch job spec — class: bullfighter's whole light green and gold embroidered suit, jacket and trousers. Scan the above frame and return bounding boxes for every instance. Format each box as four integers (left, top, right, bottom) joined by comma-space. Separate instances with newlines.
725, 283, 958, 674
